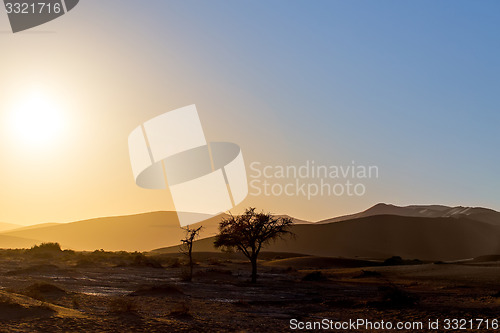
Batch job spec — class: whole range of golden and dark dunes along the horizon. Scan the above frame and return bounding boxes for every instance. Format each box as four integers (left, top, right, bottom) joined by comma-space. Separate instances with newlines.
0, 204, 500, 260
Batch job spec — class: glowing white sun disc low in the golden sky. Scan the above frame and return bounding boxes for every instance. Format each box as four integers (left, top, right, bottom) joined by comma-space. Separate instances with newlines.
7, 92, 65, 147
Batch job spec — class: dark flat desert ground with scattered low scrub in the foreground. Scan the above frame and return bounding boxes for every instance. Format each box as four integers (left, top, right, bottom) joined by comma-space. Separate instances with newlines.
0, 243, 500, 332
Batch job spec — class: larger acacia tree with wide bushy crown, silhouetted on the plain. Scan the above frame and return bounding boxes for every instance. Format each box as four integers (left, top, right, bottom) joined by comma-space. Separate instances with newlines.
214, 207, 293, 283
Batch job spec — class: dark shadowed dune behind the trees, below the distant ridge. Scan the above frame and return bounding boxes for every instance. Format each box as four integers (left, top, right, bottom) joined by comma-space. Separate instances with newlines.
154, 215, 500, 260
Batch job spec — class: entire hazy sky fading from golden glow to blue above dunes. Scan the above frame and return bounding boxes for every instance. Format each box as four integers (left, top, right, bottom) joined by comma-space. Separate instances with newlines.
0, 0, 500, 224
